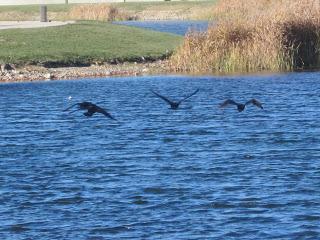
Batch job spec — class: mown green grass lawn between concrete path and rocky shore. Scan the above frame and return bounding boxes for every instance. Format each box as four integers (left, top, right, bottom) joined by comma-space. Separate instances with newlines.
0, 22, 183, 65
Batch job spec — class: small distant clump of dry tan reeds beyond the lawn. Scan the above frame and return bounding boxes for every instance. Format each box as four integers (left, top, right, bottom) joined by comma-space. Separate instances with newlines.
69, 3, 136, 21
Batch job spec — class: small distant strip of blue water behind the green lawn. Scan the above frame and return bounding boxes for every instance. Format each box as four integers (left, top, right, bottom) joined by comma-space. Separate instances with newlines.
113, 20, 208, 35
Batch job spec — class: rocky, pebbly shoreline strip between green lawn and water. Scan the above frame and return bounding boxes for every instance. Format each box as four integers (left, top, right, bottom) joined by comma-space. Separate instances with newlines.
0, 60, 171, 83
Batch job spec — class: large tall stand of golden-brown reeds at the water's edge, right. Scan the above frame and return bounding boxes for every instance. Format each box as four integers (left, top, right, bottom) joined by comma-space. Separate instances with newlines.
170, 0, 320, 73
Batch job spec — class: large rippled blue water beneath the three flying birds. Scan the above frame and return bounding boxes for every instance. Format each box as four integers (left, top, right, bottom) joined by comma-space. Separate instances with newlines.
0, 72, 320, 240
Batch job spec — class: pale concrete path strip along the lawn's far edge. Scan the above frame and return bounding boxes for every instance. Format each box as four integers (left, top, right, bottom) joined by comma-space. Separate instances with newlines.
0, 21, 75, 30
